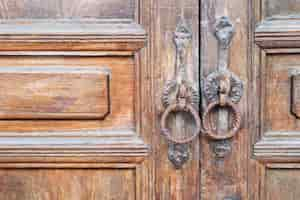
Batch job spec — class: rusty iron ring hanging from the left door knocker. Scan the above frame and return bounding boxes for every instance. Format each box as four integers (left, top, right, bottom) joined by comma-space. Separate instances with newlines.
161, 104, 201, 144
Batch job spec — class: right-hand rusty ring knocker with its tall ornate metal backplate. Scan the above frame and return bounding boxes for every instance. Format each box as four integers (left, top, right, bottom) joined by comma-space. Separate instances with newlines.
203, 17, 243, 152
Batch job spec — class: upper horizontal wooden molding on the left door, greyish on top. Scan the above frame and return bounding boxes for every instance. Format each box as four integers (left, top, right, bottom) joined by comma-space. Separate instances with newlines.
0, 19, 146, 51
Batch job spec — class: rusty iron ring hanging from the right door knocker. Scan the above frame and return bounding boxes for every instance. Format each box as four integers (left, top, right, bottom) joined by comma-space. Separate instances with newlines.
203, 99, 242, 140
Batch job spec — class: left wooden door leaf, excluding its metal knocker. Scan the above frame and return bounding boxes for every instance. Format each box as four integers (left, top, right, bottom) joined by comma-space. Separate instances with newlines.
0, 0, 200, 200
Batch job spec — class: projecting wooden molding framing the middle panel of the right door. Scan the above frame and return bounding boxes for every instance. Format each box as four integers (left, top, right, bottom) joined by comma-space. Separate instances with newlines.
253, 16, 300, 162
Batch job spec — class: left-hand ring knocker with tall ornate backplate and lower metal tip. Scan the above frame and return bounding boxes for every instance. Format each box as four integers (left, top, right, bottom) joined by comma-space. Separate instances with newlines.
161, 20, 201, 169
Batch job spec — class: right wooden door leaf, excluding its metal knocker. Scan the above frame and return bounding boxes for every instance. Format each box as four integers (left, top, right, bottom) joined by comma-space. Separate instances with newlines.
199, 0, 300, 200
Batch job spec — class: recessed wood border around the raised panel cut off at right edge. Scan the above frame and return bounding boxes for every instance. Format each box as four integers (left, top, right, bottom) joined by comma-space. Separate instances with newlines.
262, 54, 300, 132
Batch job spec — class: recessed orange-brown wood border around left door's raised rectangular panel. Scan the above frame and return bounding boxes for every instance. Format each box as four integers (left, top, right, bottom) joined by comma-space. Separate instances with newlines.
0, 56, 135, 132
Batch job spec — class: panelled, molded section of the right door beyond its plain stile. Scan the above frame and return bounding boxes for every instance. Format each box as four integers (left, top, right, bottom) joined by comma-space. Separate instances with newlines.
253, 0, 300, 200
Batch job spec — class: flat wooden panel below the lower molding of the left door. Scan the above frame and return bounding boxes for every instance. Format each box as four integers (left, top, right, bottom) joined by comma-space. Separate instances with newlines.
0, 169, 136, 200
